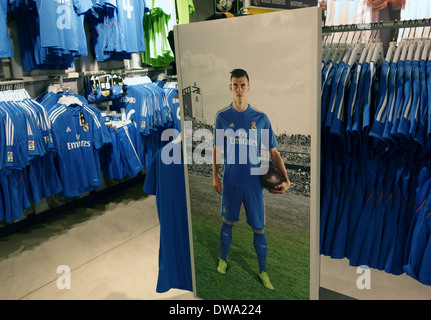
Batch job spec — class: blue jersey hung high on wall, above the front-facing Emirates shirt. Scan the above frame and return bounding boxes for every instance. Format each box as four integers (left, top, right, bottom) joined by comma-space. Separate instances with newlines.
10, 0, 92, 71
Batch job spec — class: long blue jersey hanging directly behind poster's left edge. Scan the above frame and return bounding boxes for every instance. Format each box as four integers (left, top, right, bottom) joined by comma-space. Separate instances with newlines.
144, 142, 193, 292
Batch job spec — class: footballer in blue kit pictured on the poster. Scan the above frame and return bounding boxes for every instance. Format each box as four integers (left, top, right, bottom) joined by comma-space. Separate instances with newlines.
213, 69, 290, 290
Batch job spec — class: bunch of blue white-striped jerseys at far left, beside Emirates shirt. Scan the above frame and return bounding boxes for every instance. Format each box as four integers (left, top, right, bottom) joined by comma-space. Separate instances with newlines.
0, 90, 62, 223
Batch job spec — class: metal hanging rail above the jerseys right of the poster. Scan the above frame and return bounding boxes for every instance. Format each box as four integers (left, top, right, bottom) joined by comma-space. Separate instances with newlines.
322, 18, 431, 33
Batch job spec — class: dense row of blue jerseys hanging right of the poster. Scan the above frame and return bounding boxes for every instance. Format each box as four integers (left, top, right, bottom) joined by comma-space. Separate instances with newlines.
320, 33, 431, 285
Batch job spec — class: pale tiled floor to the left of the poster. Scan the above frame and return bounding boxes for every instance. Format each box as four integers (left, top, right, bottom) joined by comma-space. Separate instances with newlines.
0, 180, 193, 300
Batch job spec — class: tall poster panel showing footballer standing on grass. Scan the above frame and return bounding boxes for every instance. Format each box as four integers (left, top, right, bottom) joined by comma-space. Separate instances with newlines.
175, 8, 321, 300
